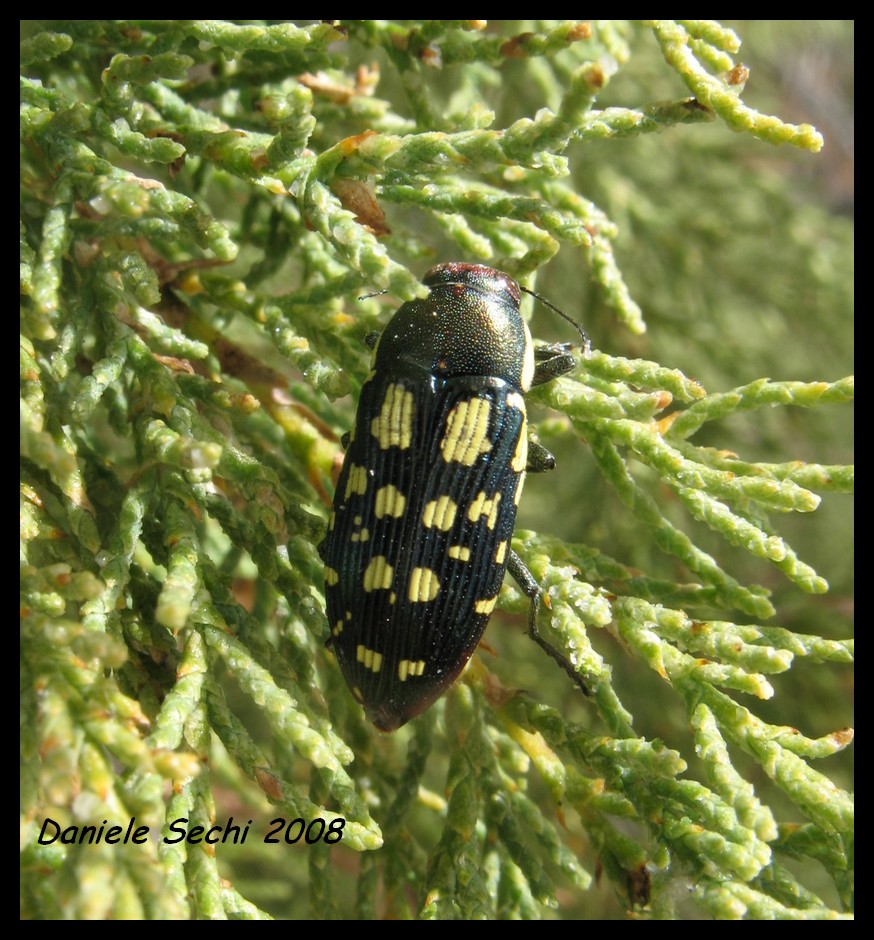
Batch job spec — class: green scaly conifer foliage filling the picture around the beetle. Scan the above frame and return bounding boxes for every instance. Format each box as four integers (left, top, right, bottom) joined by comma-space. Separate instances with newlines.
20, 21, 854, 918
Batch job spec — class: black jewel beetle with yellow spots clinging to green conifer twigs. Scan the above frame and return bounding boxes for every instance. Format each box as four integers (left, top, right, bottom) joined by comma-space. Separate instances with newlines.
319, 262, 588, 731
